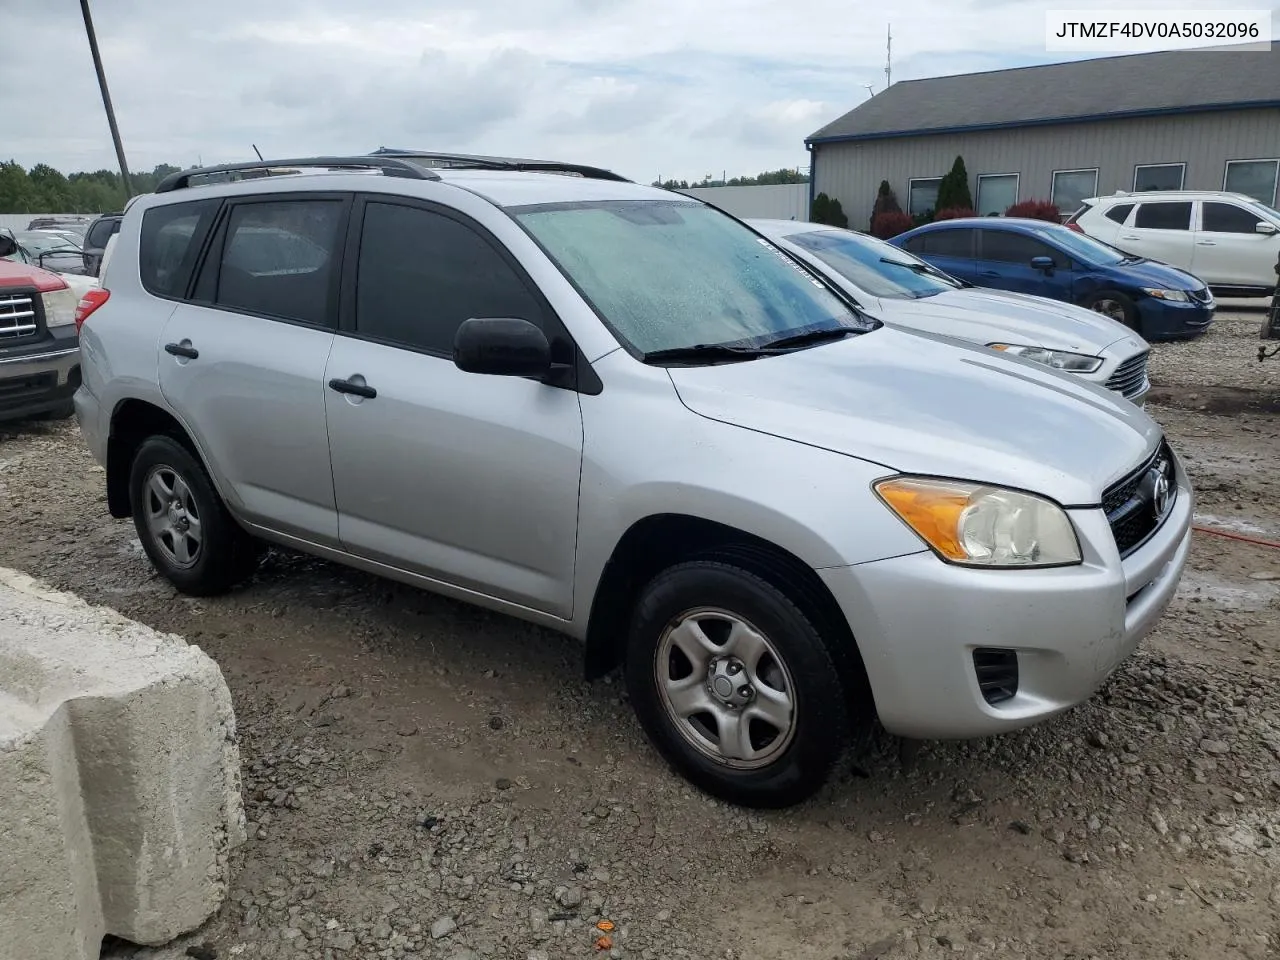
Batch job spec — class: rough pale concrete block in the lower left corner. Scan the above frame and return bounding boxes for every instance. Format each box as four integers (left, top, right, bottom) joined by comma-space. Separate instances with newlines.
0, 568, 244, 960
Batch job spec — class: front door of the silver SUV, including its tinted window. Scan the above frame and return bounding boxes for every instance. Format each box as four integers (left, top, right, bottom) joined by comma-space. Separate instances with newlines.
324, 200, 582, 618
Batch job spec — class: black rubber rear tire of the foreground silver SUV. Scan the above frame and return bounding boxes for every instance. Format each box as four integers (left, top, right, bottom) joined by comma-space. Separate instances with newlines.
129, 435, 259, 596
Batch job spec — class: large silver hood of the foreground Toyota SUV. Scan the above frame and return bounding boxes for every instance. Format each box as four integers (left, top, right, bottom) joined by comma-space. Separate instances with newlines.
669, 326, 1161, 506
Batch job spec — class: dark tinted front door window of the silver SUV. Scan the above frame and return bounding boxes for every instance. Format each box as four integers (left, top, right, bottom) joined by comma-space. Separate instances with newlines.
356, 202, 543, 356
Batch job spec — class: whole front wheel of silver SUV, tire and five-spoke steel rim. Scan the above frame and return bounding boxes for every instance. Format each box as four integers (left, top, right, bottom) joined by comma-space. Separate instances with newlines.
626, 561, 849, 808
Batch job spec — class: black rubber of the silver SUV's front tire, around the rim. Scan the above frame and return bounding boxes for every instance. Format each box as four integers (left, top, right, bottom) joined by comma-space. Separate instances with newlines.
626, 561, 849, 808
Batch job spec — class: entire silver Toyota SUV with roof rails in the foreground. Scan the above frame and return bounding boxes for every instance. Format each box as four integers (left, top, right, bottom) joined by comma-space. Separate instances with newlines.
76, 154, 1192, 806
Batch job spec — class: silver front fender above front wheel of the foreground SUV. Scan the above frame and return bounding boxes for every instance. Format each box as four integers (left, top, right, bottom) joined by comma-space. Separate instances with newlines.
571, 351, 927, 636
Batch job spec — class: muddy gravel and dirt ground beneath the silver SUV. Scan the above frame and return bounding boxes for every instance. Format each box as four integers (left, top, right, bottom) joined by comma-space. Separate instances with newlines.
0, 305, 1280, 960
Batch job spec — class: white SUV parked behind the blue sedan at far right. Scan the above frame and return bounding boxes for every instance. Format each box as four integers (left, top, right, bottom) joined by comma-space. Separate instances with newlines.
1066, 191, 1280, 297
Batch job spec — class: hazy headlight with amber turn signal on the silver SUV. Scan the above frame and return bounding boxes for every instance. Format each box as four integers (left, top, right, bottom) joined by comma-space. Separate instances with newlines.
876, 476, 1080, 567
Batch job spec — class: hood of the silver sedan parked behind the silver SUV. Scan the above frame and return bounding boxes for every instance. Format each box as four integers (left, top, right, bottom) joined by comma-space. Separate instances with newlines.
879, 288, 1135, 355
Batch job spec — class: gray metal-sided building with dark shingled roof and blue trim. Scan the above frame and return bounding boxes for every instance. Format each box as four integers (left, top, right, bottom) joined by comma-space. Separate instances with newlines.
805, 42, 1280, 230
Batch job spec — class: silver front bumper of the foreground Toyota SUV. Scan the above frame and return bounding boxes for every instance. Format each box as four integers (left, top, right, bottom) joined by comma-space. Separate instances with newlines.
818, 455, 1194, 740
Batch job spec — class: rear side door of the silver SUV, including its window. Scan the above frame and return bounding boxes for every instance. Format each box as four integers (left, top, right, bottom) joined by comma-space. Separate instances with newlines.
156, 193, 351, 545
